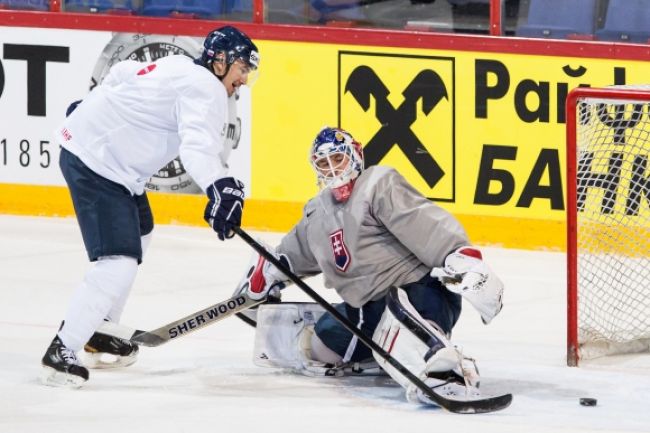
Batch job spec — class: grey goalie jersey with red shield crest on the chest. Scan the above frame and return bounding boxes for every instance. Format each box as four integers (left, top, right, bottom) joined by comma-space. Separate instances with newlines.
277, 166, 469, 308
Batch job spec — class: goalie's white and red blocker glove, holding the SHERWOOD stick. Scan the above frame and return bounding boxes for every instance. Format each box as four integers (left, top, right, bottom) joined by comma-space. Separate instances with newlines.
235, 245, 293, 301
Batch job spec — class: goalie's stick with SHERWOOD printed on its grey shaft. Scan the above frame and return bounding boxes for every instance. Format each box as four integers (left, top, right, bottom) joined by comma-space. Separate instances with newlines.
97, 288, 265, 347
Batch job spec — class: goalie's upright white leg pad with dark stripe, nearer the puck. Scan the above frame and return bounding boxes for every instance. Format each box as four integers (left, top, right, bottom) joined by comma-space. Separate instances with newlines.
373, 288, 479, 400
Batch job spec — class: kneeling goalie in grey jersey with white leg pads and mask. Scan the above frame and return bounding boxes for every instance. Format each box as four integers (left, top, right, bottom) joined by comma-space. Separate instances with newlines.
238, 127, 503, 403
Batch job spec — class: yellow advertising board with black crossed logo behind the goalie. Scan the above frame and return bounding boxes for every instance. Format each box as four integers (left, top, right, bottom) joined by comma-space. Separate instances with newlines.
252, 41, 650, 248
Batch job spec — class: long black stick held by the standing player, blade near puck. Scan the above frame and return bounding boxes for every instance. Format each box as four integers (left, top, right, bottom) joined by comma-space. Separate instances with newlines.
233, 227, 512, 413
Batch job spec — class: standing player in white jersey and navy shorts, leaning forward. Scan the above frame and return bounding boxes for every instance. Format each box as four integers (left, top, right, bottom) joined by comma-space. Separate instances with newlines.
42, 26, 259, 386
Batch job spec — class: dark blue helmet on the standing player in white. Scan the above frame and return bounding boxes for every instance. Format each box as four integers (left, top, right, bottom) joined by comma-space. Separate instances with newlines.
196, 26, 260, 70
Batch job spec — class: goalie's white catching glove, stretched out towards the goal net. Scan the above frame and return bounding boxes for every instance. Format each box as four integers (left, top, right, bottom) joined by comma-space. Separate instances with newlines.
431, 247, 503, 325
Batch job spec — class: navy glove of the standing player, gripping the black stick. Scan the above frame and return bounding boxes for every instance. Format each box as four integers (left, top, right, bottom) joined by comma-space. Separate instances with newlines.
203, 177, 244, 241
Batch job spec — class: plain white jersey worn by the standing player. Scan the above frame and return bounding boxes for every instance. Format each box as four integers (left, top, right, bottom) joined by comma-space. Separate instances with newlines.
55, 55, 232, 194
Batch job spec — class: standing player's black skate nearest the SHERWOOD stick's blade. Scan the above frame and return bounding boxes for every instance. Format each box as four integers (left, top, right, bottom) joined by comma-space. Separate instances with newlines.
84, 332, 139, 369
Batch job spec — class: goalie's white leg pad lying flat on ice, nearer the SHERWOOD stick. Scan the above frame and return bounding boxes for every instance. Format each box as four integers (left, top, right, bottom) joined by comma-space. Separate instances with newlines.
253, 303, 380, 376
